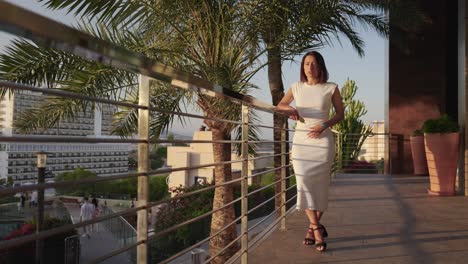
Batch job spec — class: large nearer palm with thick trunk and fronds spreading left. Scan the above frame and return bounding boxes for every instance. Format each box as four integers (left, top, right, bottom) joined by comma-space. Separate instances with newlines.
0, 0, 258, 263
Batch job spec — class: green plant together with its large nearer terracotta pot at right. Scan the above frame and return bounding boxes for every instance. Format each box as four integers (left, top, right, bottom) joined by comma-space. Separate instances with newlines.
423, 115, 460, 196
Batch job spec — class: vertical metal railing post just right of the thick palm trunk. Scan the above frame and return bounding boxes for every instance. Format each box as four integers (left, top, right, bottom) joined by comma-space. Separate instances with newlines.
241, 104, 249, 264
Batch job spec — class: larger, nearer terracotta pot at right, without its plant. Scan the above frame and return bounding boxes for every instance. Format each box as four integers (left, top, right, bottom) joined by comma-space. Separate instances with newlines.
424, 133, 460, 196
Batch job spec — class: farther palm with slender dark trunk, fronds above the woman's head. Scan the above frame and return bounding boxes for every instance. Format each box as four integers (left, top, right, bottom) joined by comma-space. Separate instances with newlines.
238, 0, 427, 208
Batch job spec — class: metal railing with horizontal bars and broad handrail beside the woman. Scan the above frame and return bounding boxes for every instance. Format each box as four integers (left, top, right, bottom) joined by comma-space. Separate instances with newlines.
0, 2, 295, 263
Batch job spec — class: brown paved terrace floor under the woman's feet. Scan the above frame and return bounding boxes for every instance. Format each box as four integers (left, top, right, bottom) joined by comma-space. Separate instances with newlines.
249, 174, 468, 264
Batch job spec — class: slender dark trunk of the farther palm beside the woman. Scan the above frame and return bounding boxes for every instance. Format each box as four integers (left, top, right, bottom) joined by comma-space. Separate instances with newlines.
268, 43, 289, 213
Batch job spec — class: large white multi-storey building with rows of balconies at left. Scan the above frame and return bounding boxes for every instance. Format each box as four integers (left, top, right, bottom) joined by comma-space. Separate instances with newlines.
0, 92, 129, 181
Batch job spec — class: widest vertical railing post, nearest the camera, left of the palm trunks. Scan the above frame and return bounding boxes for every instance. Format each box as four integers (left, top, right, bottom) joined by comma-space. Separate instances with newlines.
137, 75, 150, 264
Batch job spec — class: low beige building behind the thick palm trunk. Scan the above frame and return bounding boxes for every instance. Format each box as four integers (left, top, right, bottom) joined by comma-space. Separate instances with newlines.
167, 131, 273, 193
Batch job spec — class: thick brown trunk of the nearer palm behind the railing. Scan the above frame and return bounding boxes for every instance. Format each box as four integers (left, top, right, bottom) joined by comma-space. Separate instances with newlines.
210, 128, 239, 264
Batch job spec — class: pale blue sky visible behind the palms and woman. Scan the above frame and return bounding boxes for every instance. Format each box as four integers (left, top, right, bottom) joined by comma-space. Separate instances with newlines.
0, 0, 388, 138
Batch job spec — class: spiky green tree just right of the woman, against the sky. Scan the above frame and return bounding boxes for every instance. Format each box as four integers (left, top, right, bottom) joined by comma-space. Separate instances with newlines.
331, 79, 372, 166
